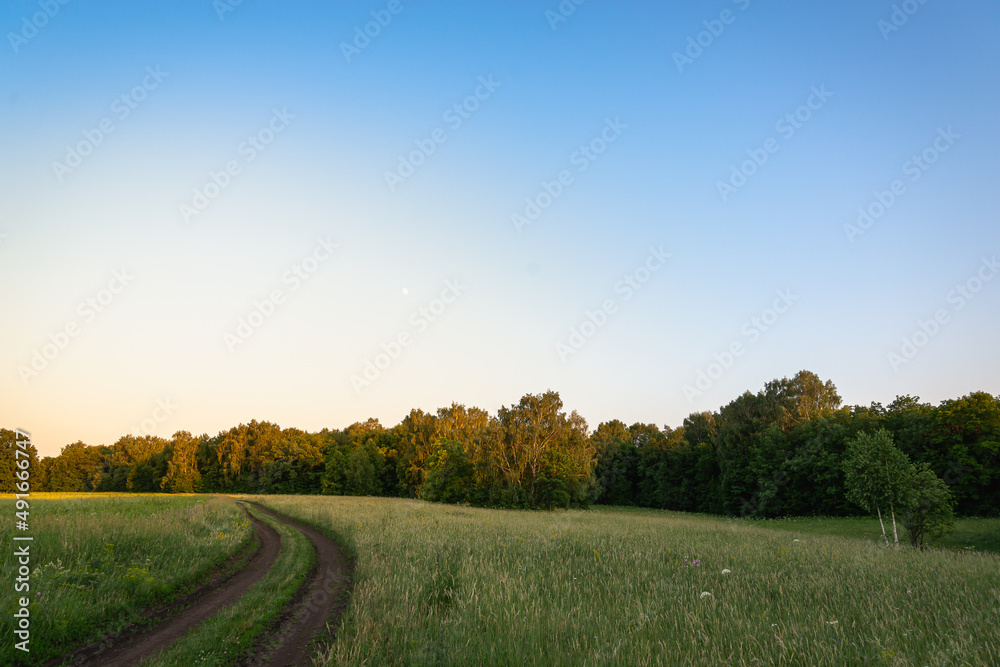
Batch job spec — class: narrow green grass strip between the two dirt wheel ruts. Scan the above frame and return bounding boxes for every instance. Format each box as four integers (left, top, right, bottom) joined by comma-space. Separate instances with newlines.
140, 507, 316, 667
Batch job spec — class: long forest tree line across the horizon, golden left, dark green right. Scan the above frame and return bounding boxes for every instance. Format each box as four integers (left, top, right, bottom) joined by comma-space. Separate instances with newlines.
0, 371, 1000, 517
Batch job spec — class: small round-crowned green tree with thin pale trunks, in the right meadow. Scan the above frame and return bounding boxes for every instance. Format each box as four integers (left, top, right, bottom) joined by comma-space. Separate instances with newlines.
844, 429, 913, 548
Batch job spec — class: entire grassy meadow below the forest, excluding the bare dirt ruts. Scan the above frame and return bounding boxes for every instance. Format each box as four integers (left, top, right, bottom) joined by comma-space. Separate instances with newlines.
0, 494, 1000, 666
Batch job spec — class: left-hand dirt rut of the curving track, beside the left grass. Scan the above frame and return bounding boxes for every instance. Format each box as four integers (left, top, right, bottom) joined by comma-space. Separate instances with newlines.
57, 512, 281, 667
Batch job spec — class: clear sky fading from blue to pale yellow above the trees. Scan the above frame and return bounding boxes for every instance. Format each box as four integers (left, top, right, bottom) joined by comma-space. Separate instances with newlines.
0, 0, 1000, 455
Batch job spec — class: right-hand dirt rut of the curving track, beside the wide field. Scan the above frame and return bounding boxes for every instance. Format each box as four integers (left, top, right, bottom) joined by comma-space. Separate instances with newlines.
246, 503, 351, 667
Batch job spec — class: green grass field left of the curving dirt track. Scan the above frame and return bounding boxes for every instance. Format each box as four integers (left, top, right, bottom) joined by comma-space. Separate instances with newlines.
0, 493, 253, 664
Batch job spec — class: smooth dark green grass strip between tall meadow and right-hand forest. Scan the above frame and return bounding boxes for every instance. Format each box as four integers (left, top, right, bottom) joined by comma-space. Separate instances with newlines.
737, 517, 1000, 553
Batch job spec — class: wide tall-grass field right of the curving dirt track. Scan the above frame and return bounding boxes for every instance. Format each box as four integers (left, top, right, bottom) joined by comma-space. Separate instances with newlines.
257, 496, 1000, 665
